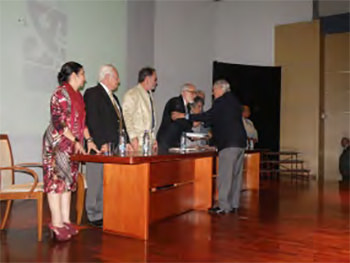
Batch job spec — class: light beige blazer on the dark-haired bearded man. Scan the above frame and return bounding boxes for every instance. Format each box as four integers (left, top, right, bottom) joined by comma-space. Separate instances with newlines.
123, 84, 156, 144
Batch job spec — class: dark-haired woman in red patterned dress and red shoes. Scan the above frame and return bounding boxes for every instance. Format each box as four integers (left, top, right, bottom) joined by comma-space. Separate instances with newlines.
43, 62, 98, 241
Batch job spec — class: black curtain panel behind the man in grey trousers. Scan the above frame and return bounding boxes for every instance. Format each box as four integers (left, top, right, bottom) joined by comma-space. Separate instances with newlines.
213, 61, 281, 151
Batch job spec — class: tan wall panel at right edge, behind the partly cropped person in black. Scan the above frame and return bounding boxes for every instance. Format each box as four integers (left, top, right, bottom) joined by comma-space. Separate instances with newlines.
323, 33, 350, 180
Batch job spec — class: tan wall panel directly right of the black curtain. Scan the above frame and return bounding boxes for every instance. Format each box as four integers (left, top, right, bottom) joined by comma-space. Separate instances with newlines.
275, 21, 320, 177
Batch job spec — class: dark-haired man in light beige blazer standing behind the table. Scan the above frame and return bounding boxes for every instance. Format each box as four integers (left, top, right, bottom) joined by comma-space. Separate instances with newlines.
122, 67, 157, 152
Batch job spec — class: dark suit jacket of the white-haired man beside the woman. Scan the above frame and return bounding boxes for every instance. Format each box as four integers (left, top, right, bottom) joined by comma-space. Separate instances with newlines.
84, 84, 129, 148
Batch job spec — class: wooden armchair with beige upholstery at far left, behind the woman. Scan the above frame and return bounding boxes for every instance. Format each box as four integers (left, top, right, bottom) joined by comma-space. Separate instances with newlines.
0, 134, 44, 241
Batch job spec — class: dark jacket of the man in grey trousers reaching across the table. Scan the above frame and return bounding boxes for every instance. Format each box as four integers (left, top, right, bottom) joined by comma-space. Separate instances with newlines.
190, 92, 247, 151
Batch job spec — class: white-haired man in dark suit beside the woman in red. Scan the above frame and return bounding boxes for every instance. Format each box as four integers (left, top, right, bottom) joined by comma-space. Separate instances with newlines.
84, 65, 132, 226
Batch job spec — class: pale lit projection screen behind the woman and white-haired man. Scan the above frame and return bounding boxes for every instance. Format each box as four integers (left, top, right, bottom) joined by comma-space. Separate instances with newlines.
0, 0, 128, 183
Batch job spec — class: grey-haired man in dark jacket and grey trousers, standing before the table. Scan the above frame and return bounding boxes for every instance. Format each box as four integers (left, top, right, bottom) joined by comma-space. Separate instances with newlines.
172, 80, 247, 214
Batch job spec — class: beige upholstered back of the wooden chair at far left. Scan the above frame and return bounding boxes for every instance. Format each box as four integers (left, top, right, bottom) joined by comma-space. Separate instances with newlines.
0, 134, 14, 190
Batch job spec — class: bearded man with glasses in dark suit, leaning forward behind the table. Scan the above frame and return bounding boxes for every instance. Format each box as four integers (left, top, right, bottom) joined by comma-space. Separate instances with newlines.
157, 83, 196, 152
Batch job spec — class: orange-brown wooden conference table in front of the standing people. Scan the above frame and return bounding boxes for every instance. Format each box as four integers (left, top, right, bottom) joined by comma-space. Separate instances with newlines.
71, 150, 259, 240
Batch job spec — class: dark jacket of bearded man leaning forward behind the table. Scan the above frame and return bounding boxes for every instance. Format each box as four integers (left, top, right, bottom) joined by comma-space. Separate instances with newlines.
157, 96, 192, 151
